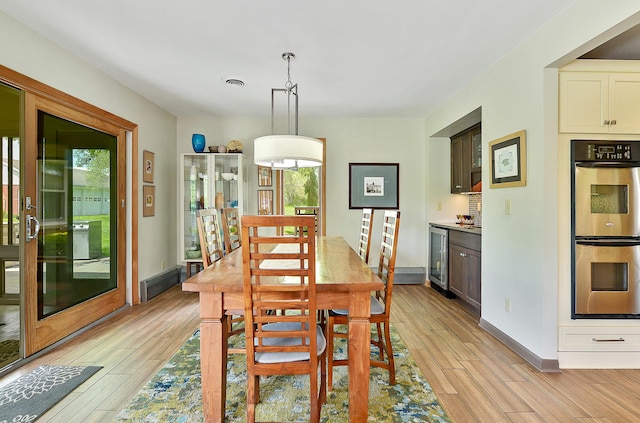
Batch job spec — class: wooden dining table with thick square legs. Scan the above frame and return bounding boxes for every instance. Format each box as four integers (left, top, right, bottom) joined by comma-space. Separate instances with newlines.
182, 236, 384, 423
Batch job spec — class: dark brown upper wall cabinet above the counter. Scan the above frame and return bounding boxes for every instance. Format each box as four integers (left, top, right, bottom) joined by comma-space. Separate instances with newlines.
451, 125, 482, 194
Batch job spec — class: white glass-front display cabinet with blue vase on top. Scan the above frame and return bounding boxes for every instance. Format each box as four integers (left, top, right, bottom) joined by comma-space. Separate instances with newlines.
178, 153, 249, 263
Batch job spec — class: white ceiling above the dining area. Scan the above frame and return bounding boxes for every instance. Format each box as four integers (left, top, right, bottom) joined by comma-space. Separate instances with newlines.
0, 0, 574, 117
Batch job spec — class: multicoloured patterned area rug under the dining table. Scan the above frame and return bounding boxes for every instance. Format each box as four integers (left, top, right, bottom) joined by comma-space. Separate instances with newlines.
114, 327, 450, 423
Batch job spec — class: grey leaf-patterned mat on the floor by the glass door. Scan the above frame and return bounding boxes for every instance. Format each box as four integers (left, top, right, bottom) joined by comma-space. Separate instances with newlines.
0, 366, 102, 422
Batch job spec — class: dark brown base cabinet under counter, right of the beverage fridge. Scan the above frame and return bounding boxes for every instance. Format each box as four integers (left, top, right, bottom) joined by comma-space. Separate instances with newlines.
449, 231, 481, 315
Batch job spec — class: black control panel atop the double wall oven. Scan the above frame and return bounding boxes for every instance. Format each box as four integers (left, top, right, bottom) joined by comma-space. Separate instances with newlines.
571, 140, 640, 162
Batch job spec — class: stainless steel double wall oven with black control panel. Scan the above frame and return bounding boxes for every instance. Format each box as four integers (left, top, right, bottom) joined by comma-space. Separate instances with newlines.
571, 140, 640, 319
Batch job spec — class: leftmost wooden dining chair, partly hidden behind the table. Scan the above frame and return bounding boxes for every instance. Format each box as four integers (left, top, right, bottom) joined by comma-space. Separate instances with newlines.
196, 208, 245, 354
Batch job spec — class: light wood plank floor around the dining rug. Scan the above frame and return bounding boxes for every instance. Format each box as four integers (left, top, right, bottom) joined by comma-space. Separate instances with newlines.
0, 285, 640, 423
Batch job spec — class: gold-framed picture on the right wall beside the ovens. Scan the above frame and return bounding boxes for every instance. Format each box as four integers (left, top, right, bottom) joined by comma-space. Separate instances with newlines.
489, 131, 527, 188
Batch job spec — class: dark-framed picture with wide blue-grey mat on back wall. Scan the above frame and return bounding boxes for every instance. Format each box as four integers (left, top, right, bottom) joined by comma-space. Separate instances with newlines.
349, 163, 400, 209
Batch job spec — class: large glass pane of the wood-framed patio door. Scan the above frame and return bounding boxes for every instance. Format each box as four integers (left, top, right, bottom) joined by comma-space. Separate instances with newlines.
36, 111, 117, 319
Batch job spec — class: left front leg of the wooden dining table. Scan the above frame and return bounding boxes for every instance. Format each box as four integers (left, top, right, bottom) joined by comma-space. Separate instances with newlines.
200, 292, 229, 423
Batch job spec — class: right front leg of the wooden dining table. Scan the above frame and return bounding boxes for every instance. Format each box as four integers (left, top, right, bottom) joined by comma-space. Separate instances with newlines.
348, 291, 371, 423
